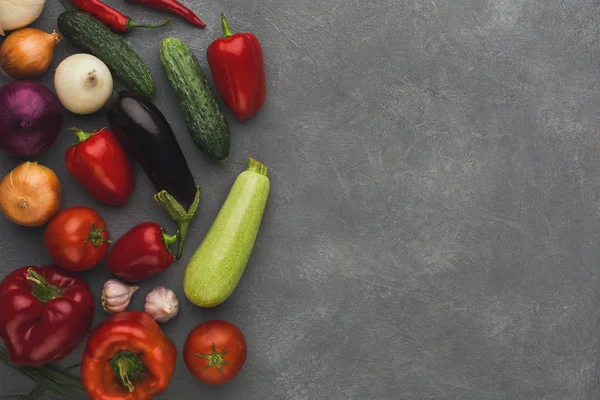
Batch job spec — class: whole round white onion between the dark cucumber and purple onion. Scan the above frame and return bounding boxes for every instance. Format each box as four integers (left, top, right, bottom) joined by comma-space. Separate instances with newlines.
54, 53, 113, 114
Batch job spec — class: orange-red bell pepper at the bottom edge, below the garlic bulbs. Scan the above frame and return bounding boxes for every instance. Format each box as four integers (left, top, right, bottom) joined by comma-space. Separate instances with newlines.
81, 311, 177, 400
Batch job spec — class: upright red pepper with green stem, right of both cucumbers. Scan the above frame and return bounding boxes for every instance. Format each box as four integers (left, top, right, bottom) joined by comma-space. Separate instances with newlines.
207, 14, 266, 121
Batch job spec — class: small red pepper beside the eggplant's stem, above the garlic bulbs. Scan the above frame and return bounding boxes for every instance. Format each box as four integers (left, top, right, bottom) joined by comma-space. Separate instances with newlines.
106, 222, 178, 282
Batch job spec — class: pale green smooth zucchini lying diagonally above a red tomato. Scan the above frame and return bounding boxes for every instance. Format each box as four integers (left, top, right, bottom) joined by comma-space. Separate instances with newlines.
183, 159, 271, 308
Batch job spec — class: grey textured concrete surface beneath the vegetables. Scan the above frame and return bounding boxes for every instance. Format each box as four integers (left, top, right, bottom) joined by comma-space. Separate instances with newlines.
0, 0, 600, 400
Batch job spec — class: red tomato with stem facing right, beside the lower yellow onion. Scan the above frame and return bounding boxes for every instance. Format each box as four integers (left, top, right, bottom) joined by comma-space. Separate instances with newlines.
44, 206, 110, 272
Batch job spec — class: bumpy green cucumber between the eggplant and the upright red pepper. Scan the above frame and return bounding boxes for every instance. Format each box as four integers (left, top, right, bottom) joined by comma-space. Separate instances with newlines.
160, 38, 229, 161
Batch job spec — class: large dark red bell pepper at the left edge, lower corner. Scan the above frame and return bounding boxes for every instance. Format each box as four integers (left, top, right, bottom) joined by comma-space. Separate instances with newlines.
0, 265, 94, 367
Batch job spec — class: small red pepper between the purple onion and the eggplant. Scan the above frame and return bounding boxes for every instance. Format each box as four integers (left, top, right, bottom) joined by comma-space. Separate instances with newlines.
65, 128, 135, 206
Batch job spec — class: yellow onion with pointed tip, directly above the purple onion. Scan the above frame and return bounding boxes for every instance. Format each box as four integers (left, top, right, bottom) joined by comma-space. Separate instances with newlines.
0, 28, 62, 79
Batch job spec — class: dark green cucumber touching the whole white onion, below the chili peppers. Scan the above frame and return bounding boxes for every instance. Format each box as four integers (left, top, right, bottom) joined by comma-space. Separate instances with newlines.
57, 11, 155, 97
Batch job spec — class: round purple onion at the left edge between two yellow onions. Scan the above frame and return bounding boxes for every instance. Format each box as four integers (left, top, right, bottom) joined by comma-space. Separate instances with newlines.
0, 81, 63, 157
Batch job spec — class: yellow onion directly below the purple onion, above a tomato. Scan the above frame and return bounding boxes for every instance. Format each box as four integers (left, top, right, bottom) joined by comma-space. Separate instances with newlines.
0, 161, 62, 226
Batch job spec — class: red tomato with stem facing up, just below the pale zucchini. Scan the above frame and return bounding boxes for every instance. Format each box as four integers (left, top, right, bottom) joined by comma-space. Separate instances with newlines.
183, 321, 246, 385
